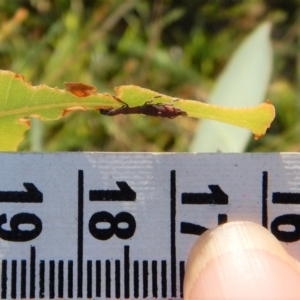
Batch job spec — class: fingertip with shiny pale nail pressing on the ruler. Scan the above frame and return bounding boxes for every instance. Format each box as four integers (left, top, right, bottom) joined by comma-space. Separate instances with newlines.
184, 222, 300, 300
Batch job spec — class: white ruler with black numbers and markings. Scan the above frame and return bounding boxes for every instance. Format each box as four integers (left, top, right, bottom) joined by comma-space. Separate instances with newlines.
0, 153, 300, 299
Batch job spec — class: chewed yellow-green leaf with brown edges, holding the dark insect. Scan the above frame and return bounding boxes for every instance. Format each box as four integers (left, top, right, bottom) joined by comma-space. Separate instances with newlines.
0, 71, 275, 151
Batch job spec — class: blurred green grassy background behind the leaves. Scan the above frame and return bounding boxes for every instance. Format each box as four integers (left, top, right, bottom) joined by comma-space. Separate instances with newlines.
0, 0, 300, 152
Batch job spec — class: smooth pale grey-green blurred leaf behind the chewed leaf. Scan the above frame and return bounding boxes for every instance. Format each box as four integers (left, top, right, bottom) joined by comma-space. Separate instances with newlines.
190, 23, 272, 152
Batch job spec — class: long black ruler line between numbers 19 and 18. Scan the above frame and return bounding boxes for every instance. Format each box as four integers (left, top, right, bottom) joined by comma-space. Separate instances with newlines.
77, 170, 84, 298
